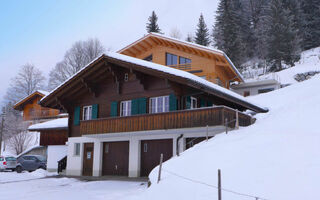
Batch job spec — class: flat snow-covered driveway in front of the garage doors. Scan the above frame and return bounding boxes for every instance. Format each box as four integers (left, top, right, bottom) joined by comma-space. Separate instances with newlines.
0, 170, 147, 200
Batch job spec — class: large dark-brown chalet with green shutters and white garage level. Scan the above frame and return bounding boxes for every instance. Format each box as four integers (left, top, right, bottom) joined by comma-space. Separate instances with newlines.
40, 52, 268, 177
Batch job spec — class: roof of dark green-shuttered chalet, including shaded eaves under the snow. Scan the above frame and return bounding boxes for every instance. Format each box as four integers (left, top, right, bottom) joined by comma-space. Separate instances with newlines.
40, 52, 268, 112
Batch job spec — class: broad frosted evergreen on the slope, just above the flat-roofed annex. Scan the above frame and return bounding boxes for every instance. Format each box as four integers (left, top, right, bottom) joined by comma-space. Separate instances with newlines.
267, 0, 300, 71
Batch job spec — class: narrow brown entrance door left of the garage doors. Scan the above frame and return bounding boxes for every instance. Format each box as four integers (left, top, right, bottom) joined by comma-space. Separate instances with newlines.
82, 143, 94, 176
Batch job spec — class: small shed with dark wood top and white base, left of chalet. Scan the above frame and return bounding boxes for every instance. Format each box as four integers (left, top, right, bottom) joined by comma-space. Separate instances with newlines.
28, 118, 68, 171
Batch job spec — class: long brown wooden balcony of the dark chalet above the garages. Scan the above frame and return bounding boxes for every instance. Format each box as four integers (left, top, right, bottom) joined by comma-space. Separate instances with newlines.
80, 106, 252, 135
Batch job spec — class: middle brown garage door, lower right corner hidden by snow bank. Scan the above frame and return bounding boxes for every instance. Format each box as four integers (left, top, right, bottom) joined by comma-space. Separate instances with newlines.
140, 139, 172, 176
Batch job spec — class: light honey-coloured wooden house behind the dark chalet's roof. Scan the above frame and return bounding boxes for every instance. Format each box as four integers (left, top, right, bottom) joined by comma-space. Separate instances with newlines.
118, 33, 243, 88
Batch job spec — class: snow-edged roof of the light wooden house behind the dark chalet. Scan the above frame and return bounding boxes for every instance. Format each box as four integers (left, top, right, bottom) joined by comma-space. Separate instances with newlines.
117, 32, 245, 82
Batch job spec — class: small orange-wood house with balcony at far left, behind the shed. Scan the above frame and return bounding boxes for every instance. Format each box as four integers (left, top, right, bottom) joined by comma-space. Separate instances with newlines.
13, 90, 59, 124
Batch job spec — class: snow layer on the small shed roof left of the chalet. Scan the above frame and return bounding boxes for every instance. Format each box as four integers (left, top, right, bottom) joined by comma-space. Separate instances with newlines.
28, 118, 68, 131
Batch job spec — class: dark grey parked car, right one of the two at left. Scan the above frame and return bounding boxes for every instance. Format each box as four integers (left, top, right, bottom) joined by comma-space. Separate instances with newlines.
16, 155, 47, 173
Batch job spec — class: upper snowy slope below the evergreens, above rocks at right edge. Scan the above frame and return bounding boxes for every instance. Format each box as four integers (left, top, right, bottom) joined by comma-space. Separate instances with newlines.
244, 47, 320, 84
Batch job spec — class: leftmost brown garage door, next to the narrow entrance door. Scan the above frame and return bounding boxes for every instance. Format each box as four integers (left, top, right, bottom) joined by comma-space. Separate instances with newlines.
102, 141, 129, 176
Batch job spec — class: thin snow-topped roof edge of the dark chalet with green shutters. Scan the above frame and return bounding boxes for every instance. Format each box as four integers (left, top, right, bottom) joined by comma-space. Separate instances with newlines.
41, 52, 268, 112
